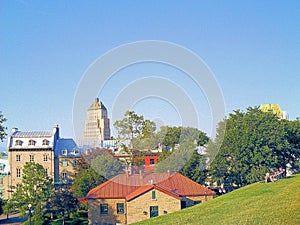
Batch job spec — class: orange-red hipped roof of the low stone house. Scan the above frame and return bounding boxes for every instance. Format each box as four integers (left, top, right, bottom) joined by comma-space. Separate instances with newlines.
86, 173, 215, 201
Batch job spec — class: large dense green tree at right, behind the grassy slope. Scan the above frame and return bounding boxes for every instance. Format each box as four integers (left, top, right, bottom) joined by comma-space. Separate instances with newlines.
207, 107, 288, 190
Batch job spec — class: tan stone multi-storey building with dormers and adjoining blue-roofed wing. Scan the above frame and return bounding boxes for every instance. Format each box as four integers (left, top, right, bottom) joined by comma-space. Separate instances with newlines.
5, 125, 80, 199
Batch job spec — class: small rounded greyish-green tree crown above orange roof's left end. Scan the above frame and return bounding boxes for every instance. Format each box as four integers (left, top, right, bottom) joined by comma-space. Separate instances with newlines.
91, 155, 124, 179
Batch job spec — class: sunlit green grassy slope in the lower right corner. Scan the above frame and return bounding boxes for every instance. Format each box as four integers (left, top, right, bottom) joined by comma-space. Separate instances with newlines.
135, 175, 300, 225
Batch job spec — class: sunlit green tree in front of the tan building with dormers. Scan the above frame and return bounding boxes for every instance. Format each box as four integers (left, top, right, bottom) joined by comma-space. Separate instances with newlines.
8, 162, 54, 224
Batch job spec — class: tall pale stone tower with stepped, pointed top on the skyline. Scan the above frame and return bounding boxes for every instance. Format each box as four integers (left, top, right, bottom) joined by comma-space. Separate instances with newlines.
83, 98, 110, 145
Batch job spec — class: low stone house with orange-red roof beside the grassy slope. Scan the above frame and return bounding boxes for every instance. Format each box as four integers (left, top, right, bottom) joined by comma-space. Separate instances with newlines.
86, 173, 215, 225
